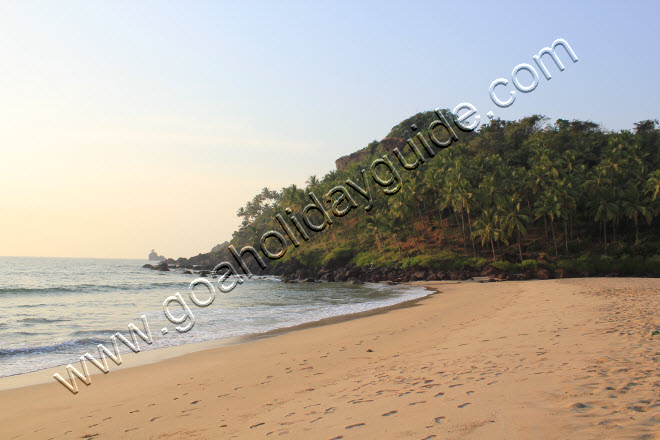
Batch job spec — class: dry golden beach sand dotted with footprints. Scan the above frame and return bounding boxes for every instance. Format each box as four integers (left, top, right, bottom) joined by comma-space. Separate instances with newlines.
0, 278, 660, 439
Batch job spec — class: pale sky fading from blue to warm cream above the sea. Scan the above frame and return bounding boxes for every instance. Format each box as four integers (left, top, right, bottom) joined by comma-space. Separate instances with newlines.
0, 0, 660, 258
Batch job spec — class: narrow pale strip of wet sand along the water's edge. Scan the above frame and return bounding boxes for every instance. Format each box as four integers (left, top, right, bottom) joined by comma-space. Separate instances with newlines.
0, 280, 444, 391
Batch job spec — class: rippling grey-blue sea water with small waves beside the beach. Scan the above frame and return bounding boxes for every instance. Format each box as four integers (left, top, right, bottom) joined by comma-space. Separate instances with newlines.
0, 257, 428, 377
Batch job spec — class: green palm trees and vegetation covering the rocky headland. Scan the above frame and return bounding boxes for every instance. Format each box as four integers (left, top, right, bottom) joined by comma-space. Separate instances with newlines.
201, 112, 660, 275
